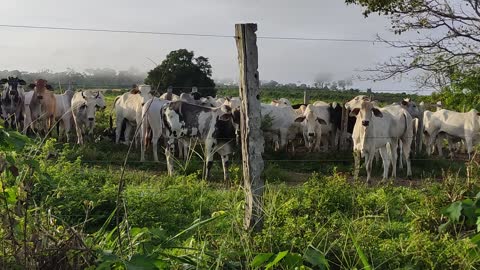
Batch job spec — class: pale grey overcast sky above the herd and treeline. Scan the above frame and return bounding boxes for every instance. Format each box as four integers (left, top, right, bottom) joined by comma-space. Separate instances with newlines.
0, 0, 420, 90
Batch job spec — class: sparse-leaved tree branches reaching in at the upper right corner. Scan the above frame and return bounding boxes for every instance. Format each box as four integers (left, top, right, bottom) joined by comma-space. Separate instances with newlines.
345, 0, 480, 86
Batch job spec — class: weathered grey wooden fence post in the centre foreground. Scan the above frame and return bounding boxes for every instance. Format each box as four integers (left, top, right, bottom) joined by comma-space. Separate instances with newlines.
235, 23, 264, 231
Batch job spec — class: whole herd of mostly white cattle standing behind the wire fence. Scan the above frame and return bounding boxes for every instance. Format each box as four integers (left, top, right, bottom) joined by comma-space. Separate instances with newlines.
0, 77, 480, 181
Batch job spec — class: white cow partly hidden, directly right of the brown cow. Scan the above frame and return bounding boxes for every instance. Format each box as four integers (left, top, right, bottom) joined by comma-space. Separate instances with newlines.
54, 90, 75, 142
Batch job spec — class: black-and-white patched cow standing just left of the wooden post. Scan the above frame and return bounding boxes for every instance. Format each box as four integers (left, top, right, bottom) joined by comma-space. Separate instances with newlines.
162, 101, 240, 180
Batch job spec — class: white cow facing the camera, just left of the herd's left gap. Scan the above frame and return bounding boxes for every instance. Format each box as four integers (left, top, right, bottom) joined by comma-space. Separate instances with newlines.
72, 91, 106, 144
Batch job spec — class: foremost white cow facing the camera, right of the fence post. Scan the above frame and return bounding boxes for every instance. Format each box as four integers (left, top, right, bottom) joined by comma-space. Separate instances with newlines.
345, 96, 413, 182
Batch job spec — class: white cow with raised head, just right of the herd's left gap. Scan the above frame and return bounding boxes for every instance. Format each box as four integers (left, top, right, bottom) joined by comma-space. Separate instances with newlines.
113, 84, 152, 145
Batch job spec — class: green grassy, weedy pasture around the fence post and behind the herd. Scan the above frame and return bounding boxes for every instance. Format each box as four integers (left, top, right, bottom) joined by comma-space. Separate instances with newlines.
0, 89, 480, 269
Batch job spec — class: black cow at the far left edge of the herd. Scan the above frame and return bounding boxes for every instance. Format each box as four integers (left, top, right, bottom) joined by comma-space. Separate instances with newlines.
0, 77, 26, 128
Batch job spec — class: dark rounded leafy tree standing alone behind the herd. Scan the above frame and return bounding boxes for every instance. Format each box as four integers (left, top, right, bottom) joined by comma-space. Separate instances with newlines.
145, 49, 216, 96
